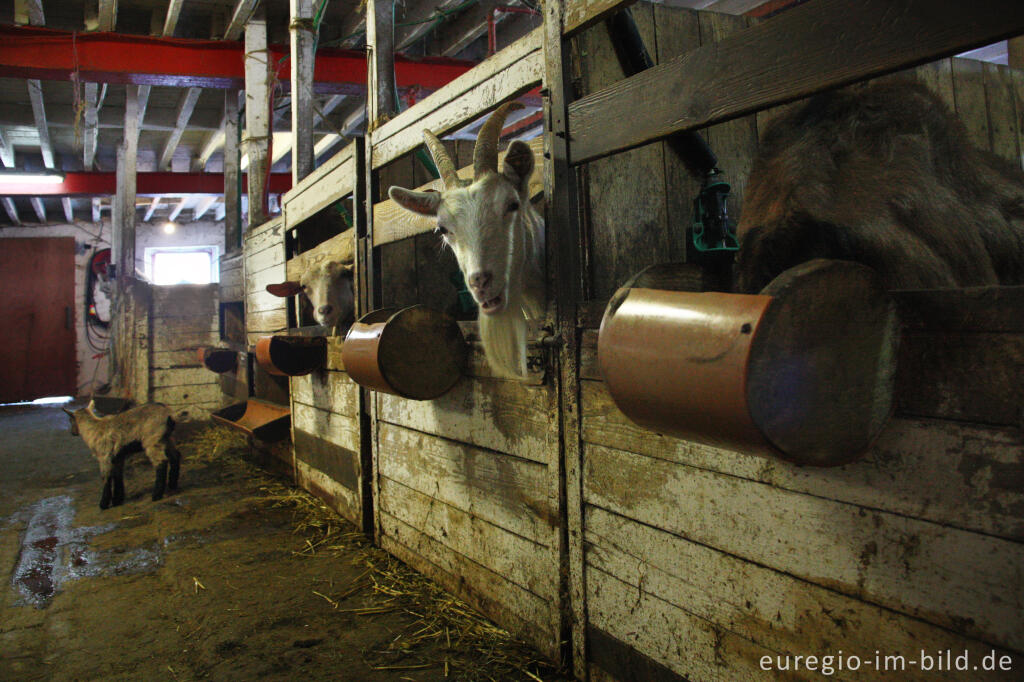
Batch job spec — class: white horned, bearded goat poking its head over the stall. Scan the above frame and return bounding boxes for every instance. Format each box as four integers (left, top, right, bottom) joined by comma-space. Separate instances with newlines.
388, 102, 545, 377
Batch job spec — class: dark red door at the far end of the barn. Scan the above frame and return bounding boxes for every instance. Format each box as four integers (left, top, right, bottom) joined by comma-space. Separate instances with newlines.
0, 237, 76, 402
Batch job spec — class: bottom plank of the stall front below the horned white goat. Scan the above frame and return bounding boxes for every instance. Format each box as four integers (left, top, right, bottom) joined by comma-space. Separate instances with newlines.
380, 513, 559, 658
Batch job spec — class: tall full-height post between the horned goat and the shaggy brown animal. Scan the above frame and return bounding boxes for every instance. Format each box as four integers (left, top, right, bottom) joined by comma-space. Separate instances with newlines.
544, 0, 587, 679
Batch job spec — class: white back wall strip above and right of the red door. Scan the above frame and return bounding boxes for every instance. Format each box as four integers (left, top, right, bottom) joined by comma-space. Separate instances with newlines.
0, 221, 111, 395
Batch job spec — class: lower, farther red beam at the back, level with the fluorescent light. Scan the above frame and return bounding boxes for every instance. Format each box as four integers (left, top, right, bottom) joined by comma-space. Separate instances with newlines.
0, 172, 292, 197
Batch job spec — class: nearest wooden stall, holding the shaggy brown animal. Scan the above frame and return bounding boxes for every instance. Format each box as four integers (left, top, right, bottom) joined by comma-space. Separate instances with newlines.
545, 0, 1024, 680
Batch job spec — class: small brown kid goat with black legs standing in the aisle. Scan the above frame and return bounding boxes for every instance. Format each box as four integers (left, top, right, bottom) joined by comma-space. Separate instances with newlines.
65, 401, 181, 509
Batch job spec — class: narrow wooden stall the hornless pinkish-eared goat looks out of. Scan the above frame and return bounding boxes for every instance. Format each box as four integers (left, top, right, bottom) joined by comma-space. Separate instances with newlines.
283, 140, 370, 527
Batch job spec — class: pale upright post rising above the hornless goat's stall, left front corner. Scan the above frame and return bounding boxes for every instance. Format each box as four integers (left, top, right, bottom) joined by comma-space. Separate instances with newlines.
290, 0, 314, 186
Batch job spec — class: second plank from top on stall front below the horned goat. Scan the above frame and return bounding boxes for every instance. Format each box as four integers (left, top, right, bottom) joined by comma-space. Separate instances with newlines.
378, 423, 558, 547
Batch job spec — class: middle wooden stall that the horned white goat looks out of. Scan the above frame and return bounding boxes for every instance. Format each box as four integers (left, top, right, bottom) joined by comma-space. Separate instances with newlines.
367, 30, 564, 658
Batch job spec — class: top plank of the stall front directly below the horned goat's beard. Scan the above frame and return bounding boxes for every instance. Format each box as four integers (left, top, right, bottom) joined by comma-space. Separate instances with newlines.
377, 378, 555, 464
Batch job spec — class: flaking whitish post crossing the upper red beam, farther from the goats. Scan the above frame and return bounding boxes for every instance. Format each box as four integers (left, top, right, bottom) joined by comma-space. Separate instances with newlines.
243, 7, 270, 227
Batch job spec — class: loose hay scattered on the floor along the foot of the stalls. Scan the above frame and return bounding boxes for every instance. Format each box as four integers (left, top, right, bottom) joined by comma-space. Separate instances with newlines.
198, 425, 571, 682
